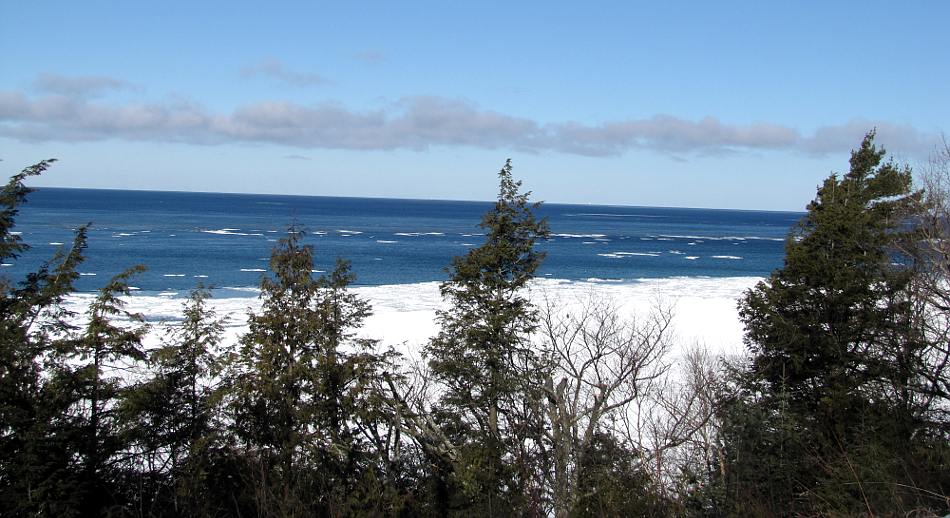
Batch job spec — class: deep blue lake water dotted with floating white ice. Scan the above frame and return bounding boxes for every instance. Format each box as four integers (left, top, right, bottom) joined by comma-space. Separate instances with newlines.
7, 188, 802, 292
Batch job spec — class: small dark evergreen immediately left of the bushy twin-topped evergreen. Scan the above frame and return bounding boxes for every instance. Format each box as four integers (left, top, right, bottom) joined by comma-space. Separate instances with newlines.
122, 286, 231, 516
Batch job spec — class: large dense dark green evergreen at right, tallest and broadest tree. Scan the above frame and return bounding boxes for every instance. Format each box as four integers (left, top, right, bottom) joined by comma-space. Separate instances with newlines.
723, 133, 946, 514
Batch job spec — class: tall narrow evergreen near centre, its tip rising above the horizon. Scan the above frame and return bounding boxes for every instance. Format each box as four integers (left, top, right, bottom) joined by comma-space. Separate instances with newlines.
425, 160, 549, 515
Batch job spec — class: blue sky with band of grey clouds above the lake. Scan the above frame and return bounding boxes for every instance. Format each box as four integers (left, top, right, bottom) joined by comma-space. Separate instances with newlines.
0, 1, 950, 210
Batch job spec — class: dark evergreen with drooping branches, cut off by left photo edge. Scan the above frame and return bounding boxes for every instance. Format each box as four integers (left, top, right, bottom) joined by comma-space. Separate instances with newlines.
0, 160, 86, 516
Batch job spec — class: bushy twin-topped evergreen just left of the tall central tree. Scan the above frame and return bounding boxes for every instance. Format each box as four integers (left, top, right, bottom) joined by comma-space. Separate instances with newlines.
228, 227, 400, 516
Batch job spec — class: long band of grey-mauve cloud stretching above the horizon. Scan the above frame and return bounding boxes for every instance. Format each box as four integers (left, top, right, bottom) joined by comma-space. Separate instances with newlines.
0, 83, 938, 156
